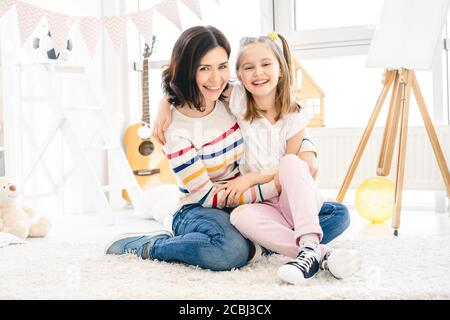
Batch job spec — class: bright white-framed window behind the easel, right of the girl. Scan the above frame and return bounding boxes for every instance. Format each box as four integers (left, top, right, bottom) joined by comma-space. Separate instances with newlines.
274, 0, 449, 127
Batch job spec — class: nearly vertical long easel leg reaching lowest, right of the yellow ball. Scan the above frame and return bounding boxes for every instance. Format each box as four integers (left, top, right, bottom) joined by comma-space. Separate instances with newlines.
392, 69, 411, 236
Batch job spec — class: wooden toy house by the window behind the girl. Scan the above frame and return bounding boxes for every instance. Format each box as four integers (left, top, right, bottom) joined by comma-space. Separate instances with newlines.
293, 57, 325, 127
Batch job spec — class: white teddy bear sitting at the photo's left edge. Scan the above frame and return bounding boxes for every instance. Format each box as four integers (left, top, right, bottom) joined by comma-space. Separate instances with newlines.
0, 177, 50, 239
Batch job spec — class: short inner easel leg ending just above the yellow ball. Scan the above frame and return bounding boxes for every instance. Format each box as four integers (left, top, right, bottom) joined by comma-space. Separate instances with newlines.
377, 71, 404, 177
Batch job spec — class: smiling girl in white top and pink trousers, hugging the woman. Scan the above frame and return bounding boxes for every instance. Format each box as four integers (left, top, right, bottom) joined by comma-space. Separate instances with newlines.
217, 33, 360, 283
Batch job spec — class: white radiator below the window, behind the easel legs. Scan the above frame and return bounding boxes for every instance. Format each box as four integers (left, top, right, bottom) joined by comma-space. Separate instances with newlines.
308, 126, 450, 190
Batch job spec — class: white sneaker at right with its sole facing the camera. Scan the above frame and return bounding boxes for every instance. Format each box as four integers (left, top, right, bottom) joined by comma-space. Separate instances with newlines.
320, 249, 362, 279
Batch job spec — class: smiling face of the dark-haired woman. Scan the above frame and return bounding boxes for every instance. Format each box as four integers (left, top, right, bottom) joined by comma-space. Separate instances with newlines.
195, 46, 230, 109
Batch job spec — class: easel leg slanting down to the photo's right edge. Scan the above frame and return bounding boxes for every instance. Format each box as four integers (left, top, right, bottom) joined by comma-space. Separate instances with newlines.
411, 72, 450, 198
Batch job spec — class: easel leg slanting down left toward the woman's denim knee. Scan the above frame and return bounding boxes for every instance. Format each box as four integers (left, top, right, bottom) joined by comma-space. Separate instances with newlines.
336, 70, 396, 202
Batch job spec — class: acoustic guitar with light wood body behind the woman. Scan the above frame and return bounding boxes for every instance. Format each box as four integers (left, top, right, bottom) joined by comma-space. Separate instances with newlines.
122, 36, 177, 203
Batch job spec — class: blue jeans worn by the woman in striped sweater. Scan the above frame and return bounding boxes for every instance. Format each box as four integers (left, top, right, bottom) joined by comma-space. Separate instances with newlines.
150, 202, 350, 271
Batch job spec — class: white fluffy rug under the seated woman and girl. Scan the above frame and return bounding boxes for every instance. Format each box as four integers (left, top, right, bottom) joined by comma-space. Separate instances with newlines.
0, 228, 450, 299
